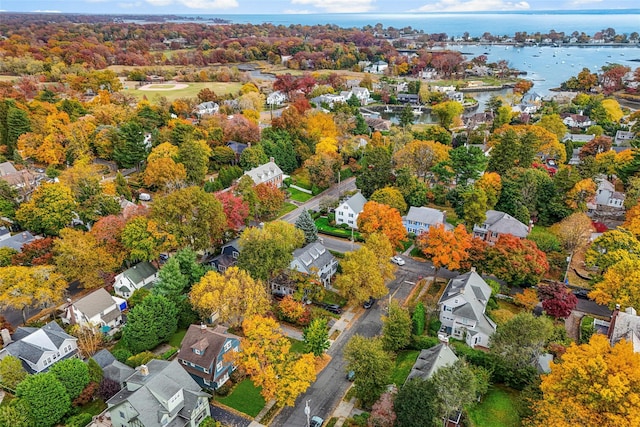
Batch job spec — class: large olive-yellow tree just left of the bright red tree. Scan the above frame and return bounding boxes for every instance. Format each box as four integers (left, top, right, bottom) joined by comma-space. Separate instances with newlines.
151, 187, 227, 250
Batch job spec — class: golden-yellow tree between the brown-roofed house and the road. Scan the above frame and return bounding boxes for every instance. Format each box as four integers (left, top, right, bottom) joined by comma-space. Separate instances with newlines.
232, 315, 316, 406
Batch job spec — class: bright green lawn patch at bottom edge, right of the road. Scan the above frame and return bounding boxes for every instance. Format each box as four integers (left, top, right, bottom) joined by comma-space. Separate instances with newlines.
468, 385, 521, 427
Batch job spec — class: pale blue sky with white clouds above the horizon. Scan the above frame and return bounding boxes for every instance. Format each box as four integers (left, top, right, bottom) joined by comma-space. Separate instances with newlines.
0, 0, 638, 14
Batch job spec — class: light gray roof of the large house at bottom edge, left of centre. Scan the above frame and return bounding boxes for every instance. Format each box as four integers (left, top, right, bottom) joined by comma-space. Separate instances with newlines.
107, 359, 209, 427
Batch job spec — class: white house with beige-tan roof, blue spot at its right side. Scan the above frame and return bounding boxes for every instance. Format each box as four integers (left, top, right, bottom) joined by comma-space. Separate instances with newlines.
62, 288, 127, 333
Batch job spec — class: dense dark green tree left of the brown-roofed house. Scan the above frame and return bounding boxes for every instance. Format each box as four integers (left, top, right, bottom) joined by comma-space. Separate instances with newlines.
122, 295, 178, 353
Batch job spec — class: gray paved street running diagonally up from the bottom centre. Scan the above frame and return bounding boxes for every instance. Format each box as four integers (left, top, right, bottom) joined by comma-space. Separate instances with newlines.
271, 259, 428, 427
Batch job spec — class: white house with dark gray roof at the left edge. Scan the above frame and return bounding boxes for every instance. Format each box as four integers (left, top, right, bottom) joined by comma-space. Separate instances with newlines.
0, 322, 78, 374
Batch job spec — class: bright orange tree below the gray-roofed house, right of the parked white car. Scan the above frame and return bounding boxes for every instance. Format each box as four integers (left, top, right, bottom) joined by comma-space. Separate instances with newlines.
416, 224, 471, 275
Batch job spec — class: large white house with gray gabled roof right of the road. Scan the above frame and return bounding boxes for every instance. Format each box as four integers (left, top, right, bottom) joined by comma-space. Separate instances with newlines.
438, 270, 496, 348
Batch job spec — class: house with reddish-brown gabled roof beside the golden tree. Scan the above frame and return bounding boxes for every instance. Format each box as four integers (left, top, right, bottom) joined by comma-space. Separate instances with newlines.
178, 325, 240, 390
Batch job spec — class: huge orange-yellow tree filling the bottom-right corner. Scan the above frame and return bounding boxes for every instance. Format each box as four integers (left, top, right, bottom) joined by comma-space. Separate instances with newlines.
531, 334, 640, 427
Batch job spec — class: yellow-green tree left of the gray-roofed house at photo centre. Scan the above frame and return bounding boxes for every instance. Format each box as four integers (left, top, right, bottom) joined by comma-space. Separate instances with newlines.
238, 221, 304, 280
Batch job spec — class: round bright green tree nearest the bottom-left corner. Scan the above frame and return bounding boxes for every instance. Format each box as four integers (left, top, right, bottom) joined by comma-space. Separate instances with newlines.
16, 372, 71, 427
